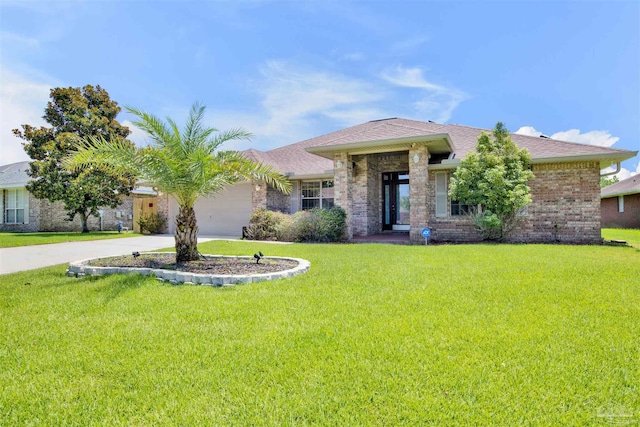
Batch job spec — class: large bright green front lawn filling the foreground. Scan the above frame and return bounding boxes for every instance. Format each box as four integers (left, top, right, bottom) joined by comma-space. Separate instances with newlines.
0, 241, 640, 426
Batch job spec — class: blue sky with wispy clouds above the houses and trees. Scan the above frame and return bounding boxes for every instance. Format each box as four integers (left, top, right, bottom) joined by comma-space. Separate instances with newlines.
0, 0, 640, 177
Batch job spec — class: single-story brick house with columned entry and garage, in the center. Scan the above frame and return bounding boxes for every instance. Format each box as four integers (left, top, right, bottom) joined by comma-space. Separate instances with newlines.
169, 118, 637, 243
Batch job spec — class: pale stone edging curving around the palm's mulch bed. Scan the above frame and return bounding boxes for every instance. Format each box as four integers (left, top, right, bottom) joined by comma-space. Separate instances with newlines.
67, 252, 311, 286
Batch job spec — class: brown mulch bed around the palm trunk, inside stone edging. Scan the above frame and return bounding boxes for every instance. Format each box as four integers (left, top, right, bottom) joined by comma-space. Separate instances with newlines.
89, 252, 298, 275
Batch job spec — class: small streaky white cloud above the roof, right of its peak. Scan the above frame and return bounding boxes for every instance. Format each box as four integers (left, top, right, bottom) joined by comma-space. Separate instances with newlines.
381, 66, 469, 123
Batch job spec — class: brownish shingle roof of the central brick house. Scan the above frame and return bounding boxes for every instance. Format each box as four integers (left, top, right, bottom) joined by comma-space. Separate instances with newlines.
245, 118, 636, 175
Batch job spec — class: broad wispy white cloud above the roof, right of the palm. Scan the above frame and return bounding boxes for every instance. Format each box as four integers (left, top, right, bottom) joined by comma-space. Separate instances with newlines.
212, 61, 389, 150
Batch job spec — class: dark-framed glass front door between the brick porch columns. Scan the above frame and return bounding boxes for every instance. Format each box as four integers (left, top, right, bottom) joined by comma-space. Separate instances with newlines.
382, 172, 410, 231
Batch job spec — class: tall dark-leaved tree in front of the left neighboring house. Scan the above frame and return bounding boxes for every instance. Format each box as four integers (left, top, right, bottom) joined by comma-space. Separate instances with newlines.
13, 85, 135, 233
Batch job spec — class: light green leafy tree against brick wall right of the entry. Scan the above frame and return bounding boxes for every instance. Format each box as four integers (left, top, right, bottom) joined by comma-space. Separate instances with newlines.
449, 122, 533, 240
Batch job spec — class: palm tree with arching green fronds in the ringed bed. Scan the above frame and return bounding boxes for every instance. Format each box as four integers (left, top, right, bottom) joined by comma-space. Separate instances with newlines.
65, 103, 291, 262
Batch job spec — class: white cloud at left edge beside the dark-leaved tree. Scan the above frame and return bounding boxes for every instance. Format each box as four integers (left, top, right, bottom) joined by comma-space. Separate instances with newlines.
0, 67, 52, 164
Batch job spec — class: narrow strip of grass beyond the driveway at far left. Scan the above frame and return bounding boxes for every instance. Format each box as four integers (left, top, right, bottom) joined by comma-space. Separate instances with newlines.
0, 231, 141, 248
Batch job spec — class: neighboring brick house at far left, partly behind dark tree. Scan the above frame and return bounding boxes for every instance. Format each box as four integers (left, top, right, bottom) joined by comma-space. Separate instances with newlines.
0, 162, 167, 232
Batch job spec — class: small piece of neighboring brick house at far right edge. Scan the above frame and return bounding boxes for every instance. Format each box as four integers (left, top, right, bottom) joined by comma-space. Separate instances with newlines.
600, 175, 640, 228
